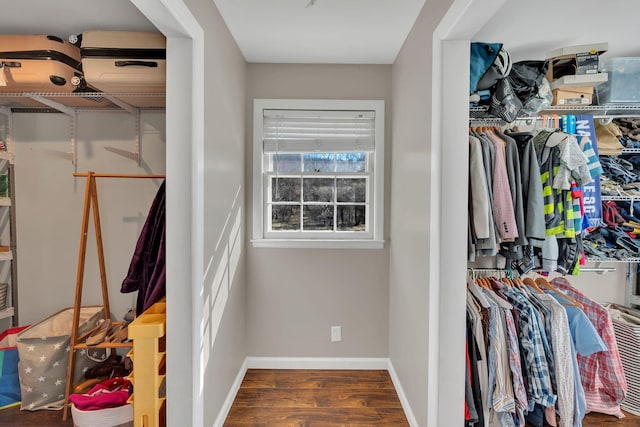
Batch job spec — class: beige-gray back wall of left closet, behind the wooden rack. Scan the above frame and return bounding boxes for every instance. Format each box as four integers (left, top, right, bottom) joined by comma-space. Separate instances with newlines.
13, 112, 165, 325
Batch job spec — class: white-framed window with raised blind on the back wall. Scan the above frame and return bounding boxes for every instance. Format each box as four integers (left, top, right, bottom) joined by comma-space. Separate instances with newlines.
252, 99, 384, 248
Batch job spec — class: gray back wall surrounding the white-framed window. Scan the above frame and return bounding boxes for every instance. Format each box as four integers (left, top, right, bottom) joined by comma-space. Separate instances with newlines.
245, 64, 393, 357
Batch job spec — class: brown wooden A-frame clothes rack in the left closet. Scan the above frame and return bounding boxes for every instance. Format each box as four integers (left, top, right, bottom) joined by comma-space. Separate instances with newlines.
62, 171, 165, 421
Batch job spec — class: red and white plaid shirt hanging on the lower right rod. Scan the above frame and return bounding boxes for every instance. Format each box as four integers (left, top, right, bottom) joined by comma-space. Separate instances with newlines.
551, 277, 627, 406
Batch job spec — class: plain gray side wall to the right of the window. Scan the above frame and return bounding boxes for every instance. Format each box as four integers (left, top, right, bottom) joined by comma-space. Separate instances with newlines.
389, 1, 456, 426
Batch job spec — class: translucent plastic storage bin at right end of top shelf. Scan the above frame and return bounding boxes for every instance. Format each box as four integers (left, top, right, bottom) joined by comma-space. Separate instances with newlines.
597, 57, 640, 105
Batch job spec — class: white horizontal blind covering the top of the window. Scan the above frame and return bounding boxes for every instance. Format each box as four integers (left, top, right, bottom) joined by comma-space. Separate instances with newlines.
263, 110, 375, 153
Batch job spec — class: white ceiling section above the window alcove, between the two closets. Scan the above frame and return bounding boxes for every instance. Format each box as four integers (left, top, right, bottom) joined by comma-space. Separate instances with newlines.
214, 0, 425, 64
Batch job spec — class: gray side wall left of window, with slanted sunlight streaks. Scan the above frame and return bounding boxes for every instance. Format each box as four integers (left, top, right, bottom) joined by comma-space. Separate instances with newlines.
185, 0, 246, 426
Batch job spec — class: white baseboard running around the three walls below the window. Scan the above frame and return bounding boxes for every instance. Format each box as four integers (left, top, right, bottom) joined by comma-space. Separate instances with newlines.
213, 357, 418, 427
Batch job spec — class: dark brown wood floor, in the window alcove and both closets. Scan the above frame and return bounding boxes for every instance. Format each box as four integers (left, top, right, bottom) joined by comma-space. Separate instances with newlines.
0, 369, 640, 427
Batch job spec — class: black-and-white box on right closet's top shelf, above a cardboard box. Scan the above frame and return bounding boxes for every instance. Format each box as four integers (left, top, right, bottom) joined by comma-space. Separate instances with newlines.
546, 43, 609, 82
